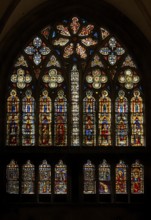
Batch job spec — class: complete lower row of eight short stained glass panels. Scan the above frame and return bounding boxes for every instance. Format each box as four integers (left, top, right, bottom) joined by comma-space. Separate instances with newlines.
6, 160, 144, 194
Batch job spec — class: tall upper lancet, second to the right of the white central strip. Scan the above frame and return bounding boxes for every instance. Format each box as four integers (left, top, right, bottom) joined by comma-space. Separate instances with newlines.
98, 90, 111, 146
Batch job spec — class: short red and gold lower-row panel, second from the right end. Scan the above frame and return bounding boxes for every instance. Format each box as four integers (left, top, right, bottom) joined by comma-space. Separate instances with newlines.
115, 160, 127, 194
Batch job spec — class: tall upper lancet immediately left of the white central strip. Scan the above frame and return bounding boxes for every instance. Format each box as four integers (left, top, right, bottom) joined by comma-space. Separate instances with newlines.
54, 90, 67, 146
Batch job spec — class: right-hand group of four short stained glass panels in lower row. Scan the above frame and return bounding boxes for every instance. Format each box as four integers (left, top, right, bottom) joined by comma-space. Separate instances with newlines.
83, 160, 144, 194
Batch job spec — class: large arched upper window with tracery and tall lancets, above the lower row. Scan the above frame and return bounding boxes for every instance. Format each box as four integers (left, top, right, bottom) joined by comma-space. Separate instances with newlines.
6, 17, 145, 147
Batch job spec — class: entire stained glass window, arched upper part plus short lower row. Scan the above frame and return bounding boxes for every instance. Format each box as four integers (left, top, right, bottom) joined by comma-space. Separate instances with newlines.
5, 16, 145, 202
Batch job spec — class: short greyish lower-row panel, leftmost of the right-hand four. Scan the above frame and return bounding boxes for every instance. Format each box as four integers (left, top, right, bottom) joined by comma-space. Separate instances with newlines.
83, 160, 96, 194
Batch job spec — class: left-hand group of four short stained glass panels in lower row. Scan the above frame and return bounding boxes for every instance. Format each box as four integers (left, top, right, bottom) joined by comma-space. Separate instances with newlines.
6, 160, 67, 194
